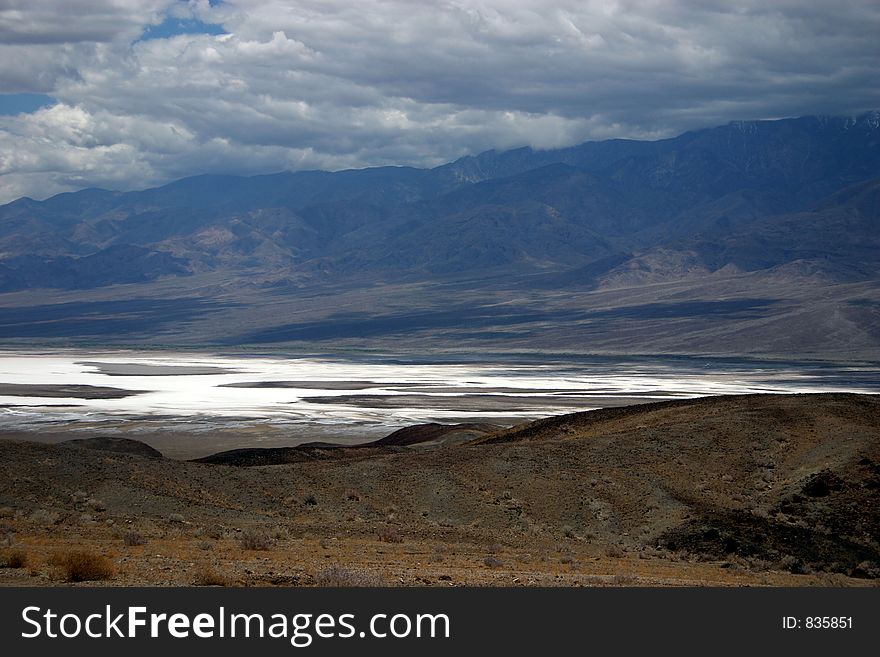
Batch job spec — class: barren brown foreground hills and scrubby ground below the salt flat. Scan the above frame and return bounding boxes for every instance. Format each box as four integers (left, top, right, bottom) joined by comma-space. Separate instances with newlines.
0, 394, 880, 585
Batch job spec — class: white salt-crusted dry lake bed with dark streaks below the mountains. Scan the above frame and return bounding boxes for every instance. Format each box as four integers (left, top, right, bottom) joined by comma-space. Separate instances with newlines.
0, 351, 880, 458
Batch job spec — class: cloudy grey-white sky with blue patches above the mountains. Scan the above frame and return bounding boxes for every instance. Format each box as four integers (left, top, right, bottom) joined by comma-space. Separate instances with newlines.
0, 0, 880, 202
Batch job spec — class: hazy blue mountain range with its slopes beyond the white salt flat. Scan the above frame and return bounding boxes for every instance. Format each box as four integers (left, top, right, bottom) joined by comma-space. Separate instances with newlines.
0, 112, 880, 359
